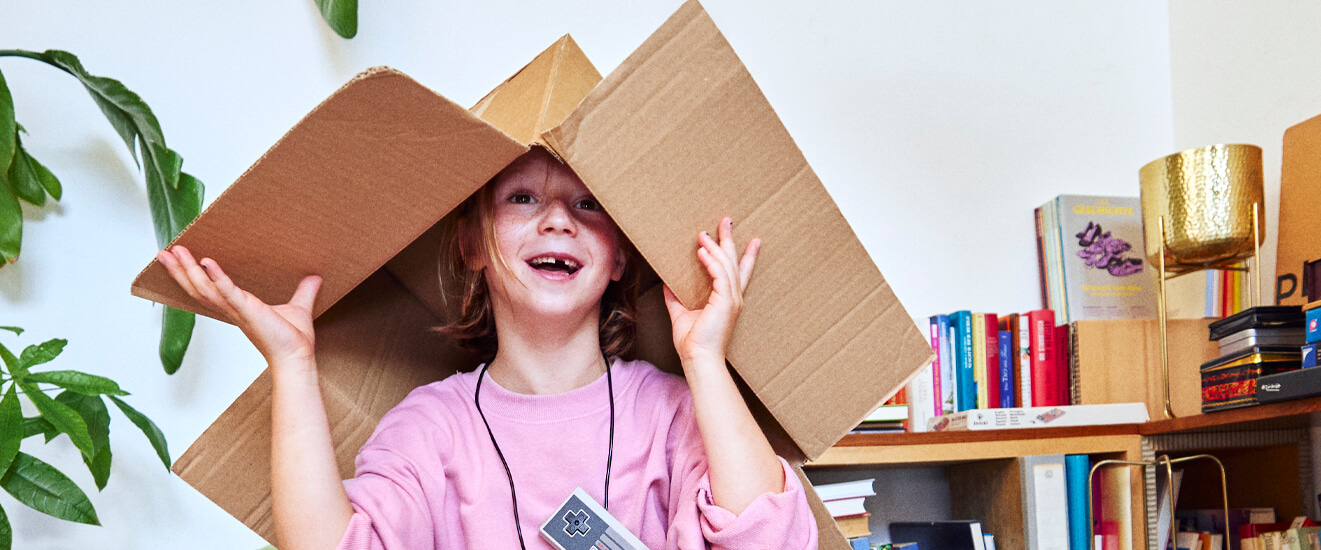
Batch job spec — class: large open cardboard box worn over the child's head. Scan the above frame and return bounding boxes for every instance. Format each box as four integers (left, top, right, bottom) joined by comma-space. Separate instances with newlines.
132, 1, 931, 547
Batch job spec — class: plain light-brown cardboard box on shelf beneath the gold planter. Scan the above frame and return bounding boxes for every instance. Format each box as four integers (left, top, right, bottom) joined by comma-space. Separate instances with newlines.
1069, 319, 1219, 420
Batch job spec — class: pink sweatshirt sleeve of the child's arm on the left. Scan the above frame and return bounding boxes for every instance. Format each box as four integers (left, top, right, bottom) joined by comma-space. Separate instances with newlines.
336, 391, 445, 550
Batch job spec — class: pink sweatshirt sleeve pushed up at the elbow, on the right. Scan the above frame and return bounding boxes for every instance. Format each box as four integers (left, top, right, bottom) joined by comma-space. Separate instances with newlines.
666, 388, 816, 550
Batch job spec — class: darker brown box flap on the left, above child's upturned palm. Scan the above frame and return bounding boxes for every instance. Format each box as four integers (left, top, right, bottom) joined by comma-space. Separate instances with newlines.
132, 69, 527, 319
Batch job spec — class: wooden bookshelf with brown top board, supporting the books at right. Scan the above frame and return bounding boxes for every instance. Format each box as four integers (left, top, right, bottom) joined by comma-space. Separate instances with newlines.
806, 397, 1321, 550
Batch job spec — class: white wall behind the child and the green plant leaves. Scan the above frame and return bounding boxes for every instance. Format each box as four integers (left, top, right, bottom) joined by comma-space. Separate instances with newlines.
0, 0, 1174, 550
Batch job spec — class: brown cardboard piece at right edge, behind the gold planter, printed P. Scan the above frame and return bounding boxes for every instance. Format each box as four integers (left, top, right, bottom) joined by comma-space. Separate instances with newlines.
1275, 116, 1321, 305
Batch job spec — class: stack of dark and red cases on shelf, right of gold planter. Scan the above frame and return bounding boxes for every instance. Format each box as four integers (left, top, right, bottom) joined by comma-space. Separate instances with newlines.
1199, 305, 1305, 413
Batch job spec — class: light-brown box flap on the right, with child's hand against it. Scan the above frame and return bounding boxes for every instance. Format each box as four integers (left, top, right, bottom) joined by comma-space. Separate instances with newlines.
543, 1, 931, 459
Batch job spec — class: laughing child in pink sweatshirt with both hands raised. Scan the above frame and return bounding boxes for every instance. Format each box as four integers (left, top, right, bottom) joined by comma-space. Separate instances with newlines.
159, 148, 816, 550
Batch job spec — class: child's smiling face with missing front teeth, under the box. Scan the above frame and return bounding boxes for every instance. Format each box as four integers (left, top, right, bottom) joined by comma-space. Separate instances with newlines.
483, 149, 624, 323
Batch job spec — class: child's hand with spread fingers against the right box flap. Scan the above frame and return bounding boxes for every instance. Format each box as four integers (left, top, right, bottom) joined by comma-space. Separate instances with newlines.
664, 217, 761, 365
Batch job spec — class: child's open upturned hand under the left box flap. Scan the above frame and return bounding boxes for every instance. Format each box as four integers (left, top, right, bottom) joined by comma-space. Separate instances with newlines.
156, 245, 321, 365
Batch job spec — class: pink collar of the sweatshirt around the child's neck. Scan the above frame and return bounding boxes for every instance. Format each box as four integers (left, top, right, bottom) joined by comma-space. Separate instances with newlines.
462, 357, 637, 424
